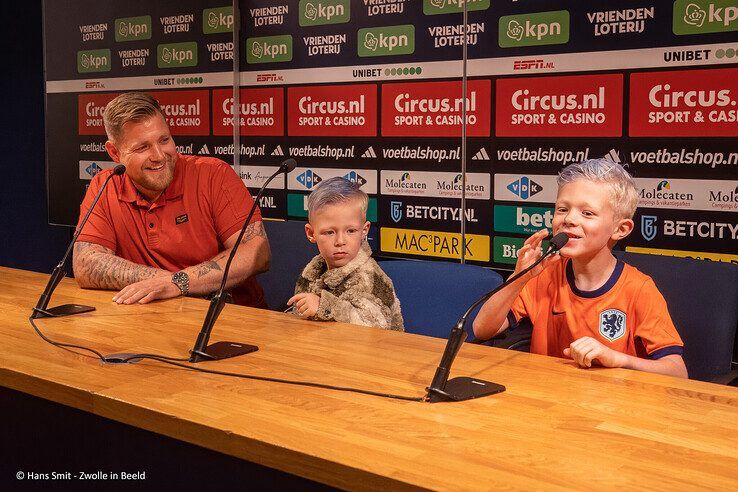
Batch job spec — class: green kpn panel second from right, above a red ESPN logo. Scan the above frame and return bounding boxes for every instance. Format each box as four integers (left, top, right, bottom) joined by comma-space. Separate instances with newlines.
498, 10, 569, 48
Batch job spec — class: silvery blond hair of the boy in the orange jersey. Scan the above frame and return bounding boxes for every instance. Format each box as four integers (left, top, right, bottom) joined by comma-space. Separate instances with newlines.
556, 159, 638, 219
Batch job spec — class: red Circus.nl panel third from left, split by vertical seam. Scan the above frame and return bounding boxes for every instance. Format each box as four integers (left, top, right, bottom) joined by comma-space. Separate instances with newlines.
213, 87, 284, 137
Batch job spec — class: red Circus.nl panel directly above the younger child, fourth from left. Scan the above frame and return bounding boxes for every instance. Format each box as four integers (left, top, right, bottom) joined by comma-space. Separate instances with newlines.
287, 84, 377, 137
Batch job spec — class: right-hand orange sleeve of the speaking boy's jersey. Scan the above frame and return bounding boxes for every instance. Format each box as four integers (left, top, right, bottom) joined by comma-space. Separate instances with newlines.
634, 278, 684, 359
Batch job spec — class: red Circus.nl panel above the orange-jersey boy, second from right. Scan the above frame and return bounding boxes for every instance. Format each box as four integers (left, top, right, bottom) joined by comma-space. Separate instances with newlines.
495, 74, 623, 137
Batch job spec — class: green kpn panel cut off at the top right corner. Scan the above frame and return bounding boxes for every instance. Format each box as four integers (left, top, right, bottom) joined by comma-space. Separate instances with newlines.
672, 0, 738, 36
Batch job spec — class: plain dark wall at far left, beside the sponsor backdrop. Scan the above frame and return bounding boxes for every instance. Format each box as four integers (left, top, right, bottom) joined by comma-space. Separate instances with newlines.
0, 0, 71, 271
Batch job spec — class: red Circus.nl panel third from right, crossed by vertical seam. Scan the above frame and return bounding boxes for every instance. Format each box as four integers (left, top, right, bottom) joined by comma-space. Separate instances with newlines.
382, 80, 492, 137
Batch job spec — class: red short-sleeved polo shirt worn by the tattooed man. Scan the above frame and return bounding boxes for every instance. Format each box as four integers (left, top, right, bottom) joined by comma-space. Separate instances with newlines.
78, 154, 264, 307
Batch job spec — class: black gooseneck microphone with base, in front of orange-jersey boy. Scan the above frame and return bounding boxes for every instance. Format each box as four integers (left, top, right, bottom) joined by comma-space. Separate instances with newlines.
425, 232, 569, 403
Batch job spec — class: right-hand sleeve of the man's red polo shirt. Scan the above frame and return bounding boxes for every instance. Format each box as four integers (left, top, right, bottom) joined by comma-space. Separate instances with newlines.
210, 162, 261, 243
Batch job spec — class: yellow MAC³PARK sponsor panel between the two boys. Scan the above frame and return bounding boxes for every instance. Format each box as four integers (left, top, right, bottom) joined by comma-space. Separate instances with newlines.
380, 227, 489, 261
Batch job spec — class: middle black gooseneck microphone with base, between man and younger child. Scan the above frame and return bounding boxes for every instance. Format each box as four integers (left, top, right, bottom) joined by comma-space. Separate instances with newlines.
189, 158, 297, 362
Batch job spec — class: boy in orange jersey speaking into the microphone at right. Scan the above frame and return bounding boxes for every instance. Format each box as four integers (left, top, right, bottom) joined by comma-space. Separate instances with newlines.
474, 159, 687, 377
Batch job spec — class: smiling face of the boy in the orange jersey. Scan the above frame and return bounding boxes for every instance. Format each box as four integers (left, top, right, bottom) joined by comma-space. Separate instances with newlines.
553, 180, 633, 260
